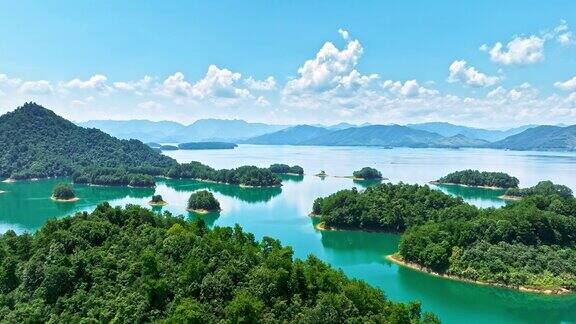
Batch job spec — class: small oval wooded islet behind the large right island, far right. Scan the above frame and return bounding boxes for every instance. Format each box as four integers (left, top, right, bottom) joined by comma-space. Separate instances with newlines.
437, 170, 520, 188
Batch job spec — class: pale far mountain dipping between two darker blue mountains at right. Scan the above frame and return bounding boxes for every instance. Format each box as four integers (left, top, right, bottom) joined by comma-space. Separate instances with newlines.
406, 122, 536, 142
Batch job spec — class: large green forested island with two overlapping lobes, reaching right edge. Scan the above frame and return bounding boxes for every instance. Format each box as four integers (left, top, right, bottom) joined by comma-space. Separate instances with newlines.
313, 183, 576, 293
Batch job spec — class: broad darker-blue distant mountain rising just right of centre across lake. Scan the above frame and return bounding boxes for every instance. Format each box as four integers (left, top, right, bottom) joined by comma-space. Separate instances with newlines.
301, 125, 486, 147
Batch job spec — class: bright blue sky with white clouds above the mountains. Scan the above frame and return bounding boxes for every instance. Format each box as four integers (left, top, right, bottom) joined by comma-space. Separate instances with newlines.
0, 0, 576, 128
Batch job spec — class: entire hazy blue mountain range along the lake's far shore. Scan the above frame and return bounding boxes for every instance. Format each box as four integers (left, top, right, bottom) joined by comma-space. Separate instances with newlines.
79, 119, 574, 150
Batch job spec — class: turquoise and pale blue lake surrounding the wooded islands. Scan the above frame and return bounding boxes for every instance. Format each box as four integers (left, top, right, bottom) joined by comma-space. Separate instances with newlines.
0, 145, 576, 323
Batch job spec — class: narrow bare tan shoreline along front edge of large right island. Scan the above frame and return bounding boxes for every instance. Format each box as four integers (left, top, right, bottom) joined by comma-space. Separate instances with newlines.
386, 254, 574, 296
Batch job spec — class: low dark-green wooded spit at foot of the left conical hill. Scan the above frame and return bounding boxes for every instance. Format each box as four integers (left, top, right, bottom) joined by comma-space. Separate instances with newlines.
72, 168, 156, 187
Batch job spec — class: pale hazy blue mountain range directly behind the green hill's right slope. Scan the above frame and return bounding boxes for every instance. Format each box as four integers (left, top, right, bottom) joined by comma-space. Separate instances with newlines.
78, 119, 287, 143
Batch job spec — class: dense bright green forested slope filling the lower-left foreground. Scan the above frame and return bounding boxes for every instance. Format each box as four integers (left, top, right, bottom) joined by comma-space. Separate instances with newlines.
0, 203, 439, 323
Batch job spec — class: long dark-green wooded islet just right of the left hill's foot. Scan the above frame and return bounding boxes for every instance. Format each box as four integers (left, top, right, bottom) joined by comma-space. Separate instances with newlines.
166, 162, 282, 187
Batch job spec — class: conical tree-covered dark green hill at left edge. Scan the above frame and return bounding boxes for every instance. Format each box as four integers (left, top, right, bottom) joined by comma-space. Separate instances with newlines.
0, 103, 176, 179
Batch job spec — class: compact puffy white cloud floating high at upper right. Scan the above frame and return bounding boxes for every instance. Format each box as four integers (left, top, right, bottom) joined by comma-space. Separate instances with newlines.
480, 35, 545, 65
